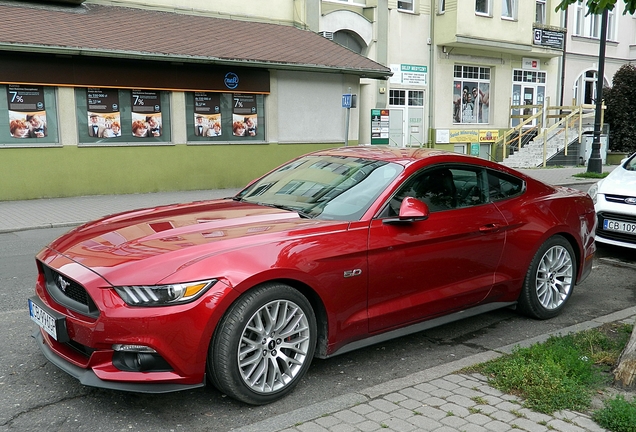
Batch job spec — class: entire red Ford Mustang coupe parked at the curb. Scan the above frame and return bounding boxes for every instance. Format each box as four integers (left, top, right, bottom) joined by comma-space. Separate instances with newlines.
29, 147, 596, 404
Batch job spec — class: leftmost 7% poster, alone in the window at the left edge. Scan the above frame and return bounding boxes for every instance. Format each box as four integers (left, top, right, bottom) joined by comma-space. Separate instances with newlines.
7, 84, 47, 138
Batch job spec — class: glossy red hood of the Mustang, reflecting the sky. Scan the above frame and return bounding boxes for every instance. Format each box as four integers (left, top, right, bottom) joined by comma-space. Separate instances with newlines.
38, 199, 343, 284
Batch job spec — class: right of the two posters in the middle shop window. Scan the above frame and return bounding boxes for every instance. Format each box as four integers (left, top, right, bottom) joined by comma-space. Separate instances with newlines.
131, 90, 163, 138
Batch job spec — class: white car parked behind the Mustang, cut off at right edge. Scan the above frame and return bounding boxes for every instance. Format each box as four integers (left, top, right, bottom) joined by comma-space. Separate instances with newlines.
588, 153, 636, 249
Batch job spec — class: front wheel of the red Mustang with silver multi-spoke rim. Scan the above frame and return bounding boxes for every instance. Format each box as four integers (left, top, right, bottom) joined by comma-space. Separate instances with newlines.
208, 283, 317, 405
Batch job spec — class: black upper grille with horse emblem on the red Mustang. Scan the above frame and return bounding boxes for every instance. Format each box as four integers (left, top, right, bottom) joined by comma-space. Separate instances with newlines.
39, 263, 99, 317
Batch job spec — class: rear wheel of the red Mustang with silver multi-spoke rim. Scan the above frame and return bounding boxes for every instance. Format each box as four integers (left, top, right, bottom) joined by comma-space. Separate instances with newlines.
517, 235, 577, 319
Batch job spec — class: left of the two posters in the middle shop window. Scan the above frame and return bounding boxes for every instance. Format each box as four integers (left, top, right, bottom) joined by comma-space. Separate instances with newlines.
86, 87, 121, 138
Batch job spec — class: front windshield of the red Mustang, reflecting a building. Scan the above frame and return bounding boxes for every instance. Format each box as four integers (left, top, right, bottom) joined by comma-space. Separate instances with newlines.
236, 155, 402, 220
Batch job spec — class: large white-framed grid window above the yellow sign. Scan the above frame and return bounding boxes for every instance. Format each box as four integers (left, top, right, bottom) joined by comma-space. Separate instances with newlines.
453, 65, 490, 124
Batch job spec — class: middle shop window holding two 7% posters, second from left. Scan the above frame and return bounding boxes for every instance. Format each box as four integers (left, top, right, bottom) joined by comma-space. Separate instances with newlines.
75, 87, 172, 145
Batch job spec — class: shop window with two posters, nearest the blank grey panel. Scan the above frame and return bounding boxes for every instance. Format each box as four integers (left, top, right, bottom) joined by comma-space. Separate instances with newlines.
186, 92, 265, 144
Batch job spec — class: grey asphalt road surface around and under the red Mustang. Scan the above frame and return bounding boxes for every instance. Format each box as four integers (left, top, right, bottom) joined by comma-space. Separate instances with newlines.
0, 224, 636, 431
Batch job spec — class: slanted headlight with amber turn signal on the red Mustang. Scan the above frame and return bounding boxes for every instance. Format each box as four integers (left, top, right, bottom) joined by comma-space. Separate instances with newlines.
115, 279, 216, 306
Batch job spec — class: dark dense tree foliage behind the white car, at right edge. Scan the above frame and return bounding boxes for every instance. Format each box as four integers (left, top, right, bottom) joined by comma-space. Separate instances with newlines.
603, 64, 636, 153
